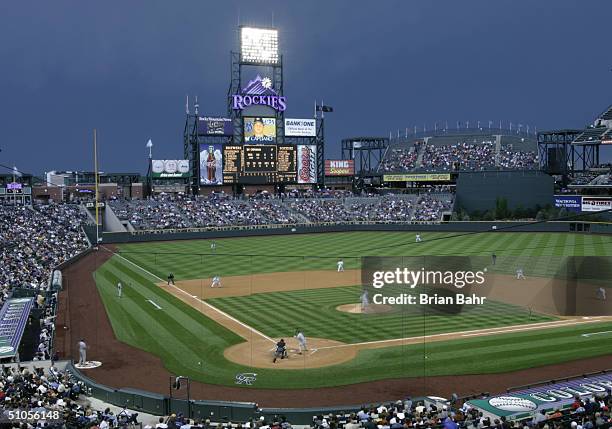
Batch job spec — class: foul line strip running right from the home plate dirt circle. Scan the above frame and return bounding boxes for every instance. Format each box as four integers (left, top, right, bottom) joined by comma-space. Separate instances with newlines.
318, 319, 604, 350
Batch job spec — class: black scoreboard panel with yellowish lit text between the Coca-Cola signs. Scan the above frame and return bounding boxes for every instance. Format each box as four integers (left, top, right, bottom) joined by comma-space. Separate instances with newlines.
223, 144, 297, 184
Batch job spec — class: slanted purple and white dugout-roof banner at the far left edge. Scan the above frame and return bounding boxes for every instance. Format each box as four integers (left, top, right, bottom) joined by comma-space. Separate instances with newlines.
0, 298, 34, 359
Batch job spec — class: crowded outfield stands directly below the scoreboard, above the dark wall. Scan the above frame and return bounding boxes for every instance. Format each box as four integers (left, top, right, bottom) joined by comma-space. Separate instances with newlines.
110, 193, 452, 230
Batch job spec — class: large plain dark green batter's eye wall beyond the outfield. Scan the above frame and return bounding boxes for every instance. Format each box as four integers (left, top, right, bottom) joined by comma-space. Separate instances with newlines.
455, 171, 554, 212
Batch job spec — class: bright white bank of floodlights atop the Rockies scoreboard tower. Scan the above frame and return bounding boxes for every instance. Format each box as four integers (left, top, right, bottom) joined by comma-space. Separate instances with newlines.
240, 27, 278, 65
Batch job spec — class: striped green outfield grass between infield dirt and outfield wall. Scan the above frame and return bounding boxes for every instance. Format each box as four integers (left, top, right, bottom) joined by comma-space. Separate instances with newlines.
119, 232, 612, 280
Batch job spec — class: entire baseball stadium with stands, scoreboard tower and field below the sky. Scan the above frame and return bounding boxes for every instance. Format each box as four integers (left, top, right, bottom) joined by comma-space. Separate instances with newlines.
0, 6, 612, 429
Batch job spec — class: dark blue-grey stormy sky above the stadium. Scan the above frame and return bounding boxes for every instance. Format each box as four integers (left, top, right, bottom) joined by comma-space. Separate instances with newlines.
0, 0, 612, 173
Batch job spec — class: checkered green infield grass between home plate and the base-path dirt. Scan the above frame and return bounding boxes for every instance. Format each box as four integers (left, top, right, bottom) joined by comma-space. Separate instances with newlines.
207, 286, 556, 343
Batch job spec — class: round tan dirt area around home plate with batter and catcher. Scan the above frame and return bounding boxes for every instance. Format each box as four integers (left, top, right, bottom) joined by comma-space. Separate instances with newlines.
223, 337, 357, 369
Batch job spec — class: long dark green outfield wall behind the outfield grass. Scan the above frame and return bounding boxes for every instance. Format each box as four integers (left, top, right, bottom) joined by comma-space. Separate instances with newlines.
85, 222, 612, 243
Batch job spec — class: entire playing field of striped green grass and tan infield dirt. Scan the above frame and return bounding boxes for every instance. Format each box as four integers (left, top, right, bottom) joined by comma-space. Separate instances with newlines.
89, 232, 612, 389
